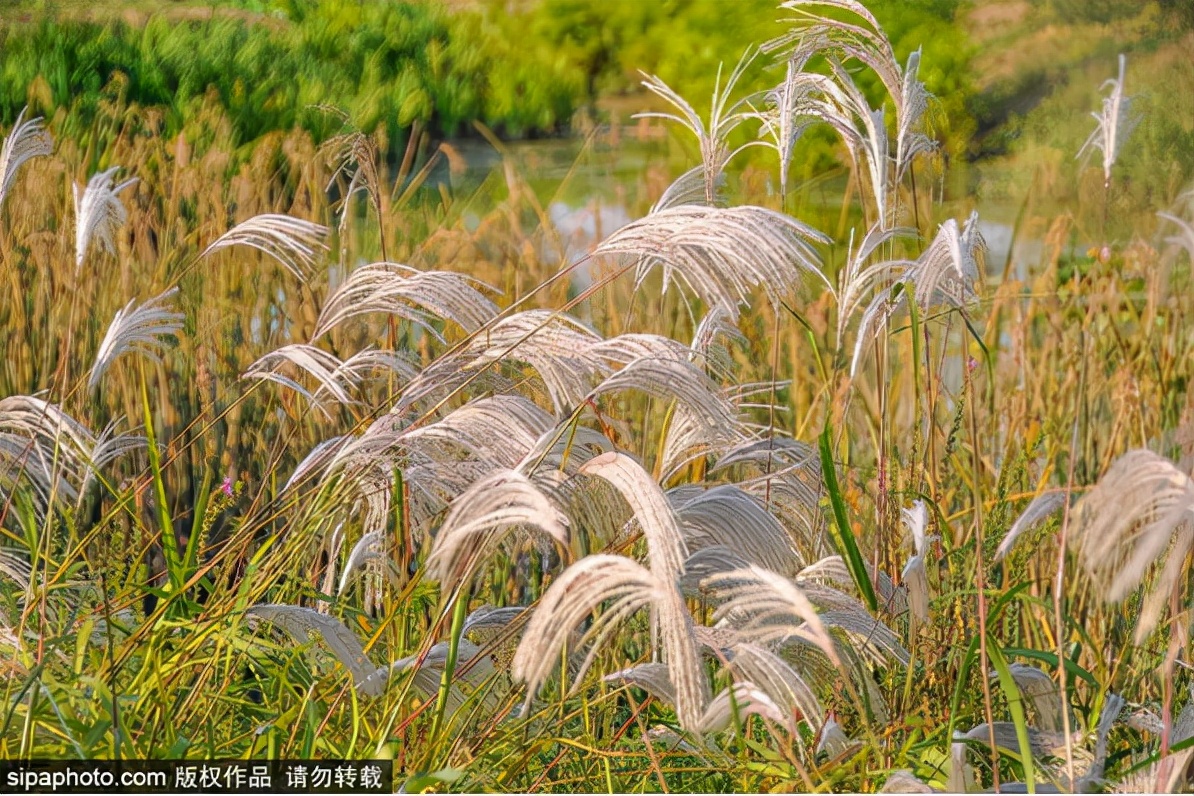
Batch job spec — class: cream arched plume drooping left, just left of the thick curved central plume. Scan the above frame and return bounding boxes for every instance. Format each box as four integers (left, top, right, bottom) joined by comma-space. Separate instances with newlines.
426, 470, 570, 587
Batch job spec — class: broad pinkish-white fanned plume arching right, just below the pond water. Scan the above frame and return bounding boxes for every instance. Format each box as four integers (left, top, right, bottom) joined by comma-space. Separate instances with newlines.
593, 205, 833, 321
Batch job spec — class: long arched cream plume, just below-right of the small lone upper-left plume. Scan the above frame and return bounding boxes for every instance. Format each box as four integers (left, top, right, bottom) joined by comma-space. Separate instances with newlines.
312, 263, 498, 340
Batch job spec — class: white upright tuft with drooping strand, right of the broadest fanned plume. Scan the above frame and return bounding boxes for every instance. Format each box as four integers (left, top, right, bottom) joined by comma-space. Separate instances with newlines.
850, 212, 986, 376
